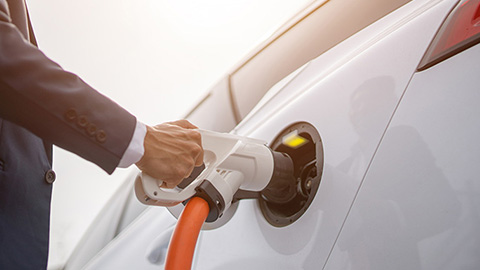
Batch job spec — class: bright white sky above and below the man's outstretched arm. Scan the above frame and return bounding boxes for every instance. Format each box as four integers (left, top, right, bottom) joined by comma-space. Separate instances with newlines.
27, 0, 311, 269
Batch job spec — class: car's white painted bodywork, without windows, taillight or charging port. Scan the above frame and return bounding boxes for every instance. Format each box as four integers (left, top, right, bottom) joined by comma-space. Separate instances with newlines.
71, 0, 480, 269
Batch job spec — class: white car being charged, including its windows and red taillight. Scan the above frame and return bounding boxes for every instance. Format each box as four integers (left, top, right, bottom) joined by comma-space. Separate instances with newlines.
66, 0, 480, 270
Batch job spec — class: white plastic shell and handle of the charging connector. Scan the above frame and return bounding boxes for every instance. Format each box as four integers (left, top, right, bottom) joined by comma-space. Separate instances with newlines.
135, 130, 274, 206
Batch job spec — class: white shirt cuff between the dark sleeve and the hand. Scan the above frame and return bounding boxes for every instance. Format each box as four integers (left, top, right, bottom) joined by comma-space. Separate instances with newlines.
118, 120, 147, 168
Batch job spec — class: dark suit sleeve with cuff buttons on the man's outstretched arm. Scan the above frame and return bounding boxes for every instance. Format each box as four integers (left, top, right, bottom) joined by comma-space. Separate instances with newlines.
0, 4, 136, 173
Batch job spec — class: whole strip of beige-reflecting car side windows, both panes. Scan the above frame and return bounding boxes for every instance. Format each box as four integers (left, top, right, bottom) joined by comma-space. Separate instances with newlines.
182, 0, 411, 126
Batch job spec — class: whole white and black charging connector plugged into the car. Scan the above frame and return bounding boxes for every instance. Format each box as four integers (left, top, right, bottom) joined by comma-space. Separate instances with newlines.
135, 130, 296, 229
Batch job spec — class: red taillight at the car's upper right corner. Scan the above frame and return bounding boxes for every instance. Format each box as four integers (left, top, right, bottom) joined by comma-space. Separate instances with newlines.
418, 0, 480, 70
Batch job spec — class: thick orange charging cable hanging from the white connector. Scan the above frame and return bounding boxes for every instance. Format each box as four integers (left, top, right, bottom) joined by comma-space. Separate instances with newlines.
165, 197, 210, 270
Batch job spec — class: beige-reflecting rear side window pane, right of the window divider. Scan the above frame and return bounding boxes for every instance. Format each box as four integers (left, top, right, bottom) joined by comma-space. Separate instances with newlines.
230, 0, 411, 122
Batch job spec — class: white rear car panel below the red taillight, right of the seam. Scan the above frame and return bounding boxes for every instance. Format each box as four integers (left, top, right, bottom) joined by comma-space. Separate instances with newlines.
327, 45, 480, 269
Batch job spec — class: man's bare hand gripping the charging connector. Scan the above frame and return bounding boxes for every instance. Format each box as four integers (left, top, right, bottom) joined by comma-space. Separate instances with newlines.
136, 120, 203, 188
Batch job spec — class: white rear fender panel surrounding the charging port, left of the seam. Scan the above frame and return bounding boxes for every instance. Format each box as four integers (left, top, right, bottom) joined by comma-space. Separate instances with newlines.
191, 1, 458, 269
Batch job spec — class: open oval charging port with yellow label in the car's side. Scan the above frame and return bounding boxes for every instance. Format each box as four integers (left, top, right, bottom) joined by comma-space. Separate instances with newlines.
258, 122, 323, 227
